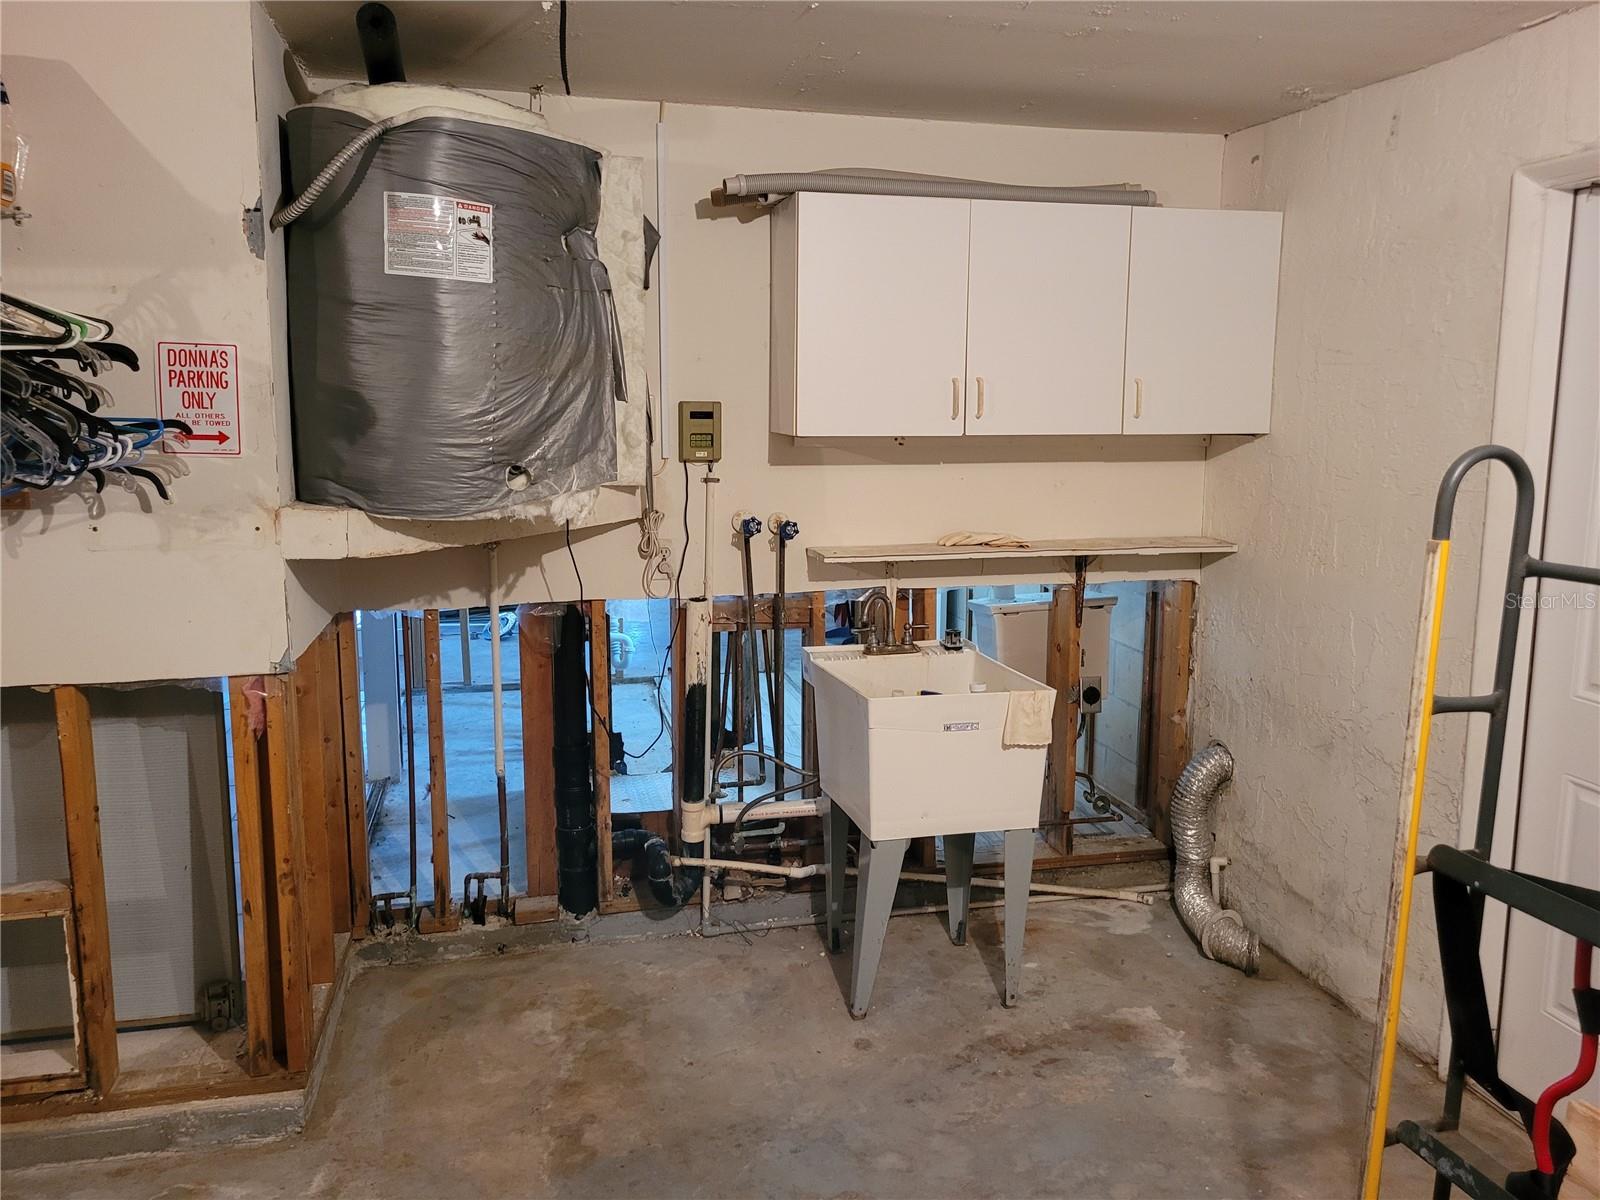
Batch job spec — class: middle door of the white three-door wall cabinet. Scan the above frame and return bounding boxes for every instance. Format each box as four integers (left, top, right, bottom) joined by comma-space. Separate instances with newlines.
966, 200, 1130, 434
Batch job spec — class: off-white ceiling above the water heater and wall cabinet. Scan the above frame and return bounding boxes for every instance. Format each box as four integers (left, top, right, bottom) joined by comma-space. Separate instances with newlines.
267, 0, 1574, 133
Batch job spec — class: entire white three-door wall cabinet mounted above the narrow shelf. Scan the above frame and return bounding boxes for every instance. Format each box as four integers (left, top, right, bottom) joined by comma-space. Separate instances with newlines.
771, 192, 1282, 437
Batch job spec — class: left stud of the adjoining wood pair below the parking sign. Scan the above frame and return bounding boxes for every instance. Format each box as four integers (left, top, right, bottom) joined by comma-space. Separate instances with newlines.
227, 678, 274, 1075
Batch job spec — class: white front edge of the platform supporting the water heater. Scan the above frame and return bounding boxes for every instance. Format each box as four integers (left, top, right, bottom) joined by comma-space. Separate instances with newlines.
278, 488, 638, 562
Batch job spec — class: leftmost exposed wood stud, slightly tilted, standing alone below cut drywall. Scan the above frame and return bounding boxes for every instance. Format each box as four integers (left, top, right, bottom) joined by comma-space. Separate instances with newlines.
54, 688, 118, 1094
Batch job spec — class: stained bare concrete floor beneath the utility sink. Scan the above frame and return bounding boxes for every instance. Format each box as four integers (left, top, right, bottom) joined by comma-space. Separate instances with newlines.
3, 901, 1526, 1200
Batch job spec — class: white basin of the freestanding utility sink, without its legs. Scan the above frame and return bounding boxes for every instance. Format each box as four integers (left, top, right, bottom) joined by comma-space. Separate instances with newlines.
805, 642, 1056, 842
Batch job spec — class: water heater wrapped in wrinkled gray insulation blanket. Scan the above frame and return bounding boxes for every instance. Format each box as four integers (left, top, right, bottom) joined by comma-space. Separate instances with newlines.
288, 107, 626, 518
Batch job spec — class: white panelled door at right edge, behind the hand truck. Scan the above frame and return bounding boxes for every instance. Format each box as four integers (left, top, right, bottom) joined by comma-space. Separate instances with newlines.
1499, 190, 1600, 1115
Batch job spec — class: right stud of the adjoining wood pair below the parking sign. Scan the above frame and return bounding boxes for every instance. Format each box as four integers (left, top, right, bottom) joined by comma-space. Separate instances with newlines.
264, 675, 312, 1070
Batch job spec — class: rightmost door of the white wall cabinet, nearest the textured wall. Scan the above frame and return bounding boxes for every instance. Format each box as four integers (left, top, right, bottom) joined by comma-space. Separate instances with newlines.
1123, 208, 1283, 434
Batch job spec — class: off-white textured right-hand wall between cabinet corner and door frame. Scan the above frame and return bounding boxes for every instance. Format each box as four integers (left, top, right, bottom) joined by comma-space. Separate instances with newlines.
1194, 8, 1600, 1053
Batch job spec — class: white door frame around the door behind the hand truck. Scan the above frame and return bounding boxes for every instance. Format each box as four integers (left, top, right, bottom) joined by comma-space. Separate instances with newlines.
1438, 144, 1600, 1078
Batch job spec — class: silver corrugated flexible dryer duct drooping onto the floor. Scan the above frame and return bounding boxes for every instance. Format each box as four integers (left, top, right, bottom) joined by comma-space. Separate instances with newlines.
1171, 742, 1261, 974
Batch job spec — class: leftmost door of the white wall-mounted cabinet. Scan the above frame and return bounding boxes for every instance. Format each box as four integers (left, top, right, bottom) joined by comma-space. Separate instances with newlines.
795, 192, 971, 437
